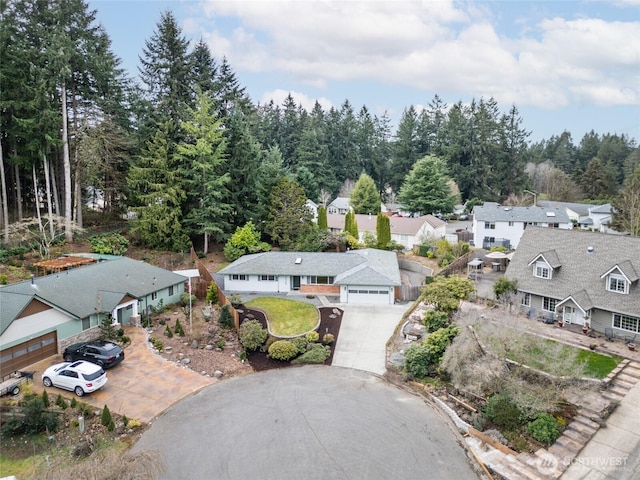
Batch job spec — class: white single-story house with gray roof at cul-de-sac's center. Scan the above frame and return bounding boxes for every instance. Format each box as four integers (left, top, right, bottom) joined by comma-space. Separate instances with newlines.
217, 248, 401, 305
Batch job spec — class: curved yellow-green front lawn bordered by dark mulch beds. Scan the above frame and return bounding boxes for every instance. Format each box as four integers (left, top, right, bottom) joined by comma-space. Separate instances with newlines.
245, 297, 319, 337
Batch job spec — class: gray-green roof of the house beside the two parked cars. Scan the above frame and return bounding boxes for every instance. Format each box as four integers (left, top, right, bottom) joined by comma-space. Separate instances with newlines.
0, 257, 185, 333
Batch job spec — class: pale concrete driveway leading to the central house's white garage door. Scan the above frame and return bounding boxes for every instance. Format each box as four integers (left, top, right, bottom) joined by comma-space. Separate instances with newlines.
330, 304, 407, 375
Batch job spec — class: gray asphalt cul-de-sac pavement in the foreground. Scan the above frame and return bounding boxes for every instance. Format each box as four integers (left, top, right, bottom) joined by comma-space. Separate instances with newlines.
133, 366, 477, 480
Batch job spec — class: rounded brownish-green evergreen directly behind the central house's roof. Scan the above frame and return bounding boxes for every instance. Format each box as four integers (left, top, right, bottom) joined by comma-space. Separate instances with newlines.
265, 178, 313, 249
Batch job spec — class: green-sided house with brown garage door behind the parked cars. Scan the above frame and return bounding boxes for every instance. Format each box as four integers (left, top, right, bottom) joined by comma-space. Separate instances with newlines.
0, 257, 186, 374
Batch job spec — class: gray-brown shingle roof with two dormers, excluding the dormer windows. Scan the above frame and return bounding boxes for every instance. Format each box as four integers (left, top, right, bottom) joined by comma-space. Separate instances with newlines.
505, 227, 640, 317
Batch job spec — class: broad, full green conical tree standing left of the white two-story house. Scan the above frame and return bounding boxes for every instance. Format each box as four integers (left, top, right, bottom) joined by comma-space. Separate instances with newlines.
398, 156, 454, 214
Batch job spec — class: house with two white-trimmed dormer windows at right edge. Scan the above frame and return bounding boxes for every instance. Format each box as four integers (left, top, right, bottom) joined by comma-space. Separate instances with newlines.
505, 227, 640, 339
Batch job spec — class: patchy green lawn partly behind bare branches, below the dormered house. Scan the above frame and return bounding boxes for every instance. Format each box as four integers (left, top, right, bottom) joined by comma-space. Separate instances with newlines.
509, 340, 622, 378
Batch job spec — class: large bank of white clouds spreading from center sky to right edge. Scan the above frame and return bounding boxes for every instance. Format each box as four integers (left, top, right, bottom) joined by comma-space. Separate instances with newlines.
189, 0, 640, 108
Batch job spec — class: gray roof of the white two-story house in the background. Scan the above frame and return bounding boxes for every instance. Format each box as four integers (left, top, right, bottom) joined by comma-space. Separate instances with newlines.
473, 202, 571, 223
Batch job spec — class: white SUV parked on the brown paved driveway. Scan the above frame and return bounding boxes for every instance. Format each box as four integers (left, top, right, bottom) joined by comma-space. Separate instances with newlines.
42, 360, 107, 397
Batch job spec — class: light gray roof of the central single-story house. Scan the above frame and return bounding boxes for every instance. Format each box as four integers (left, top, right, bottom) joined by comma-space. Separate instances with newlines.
218, 248, 401, 285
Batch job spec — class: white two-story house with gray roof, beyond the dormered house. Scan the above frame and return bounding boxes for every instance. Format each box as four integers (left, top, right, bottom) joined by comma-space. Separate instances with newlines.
471, 202, 573, 250
